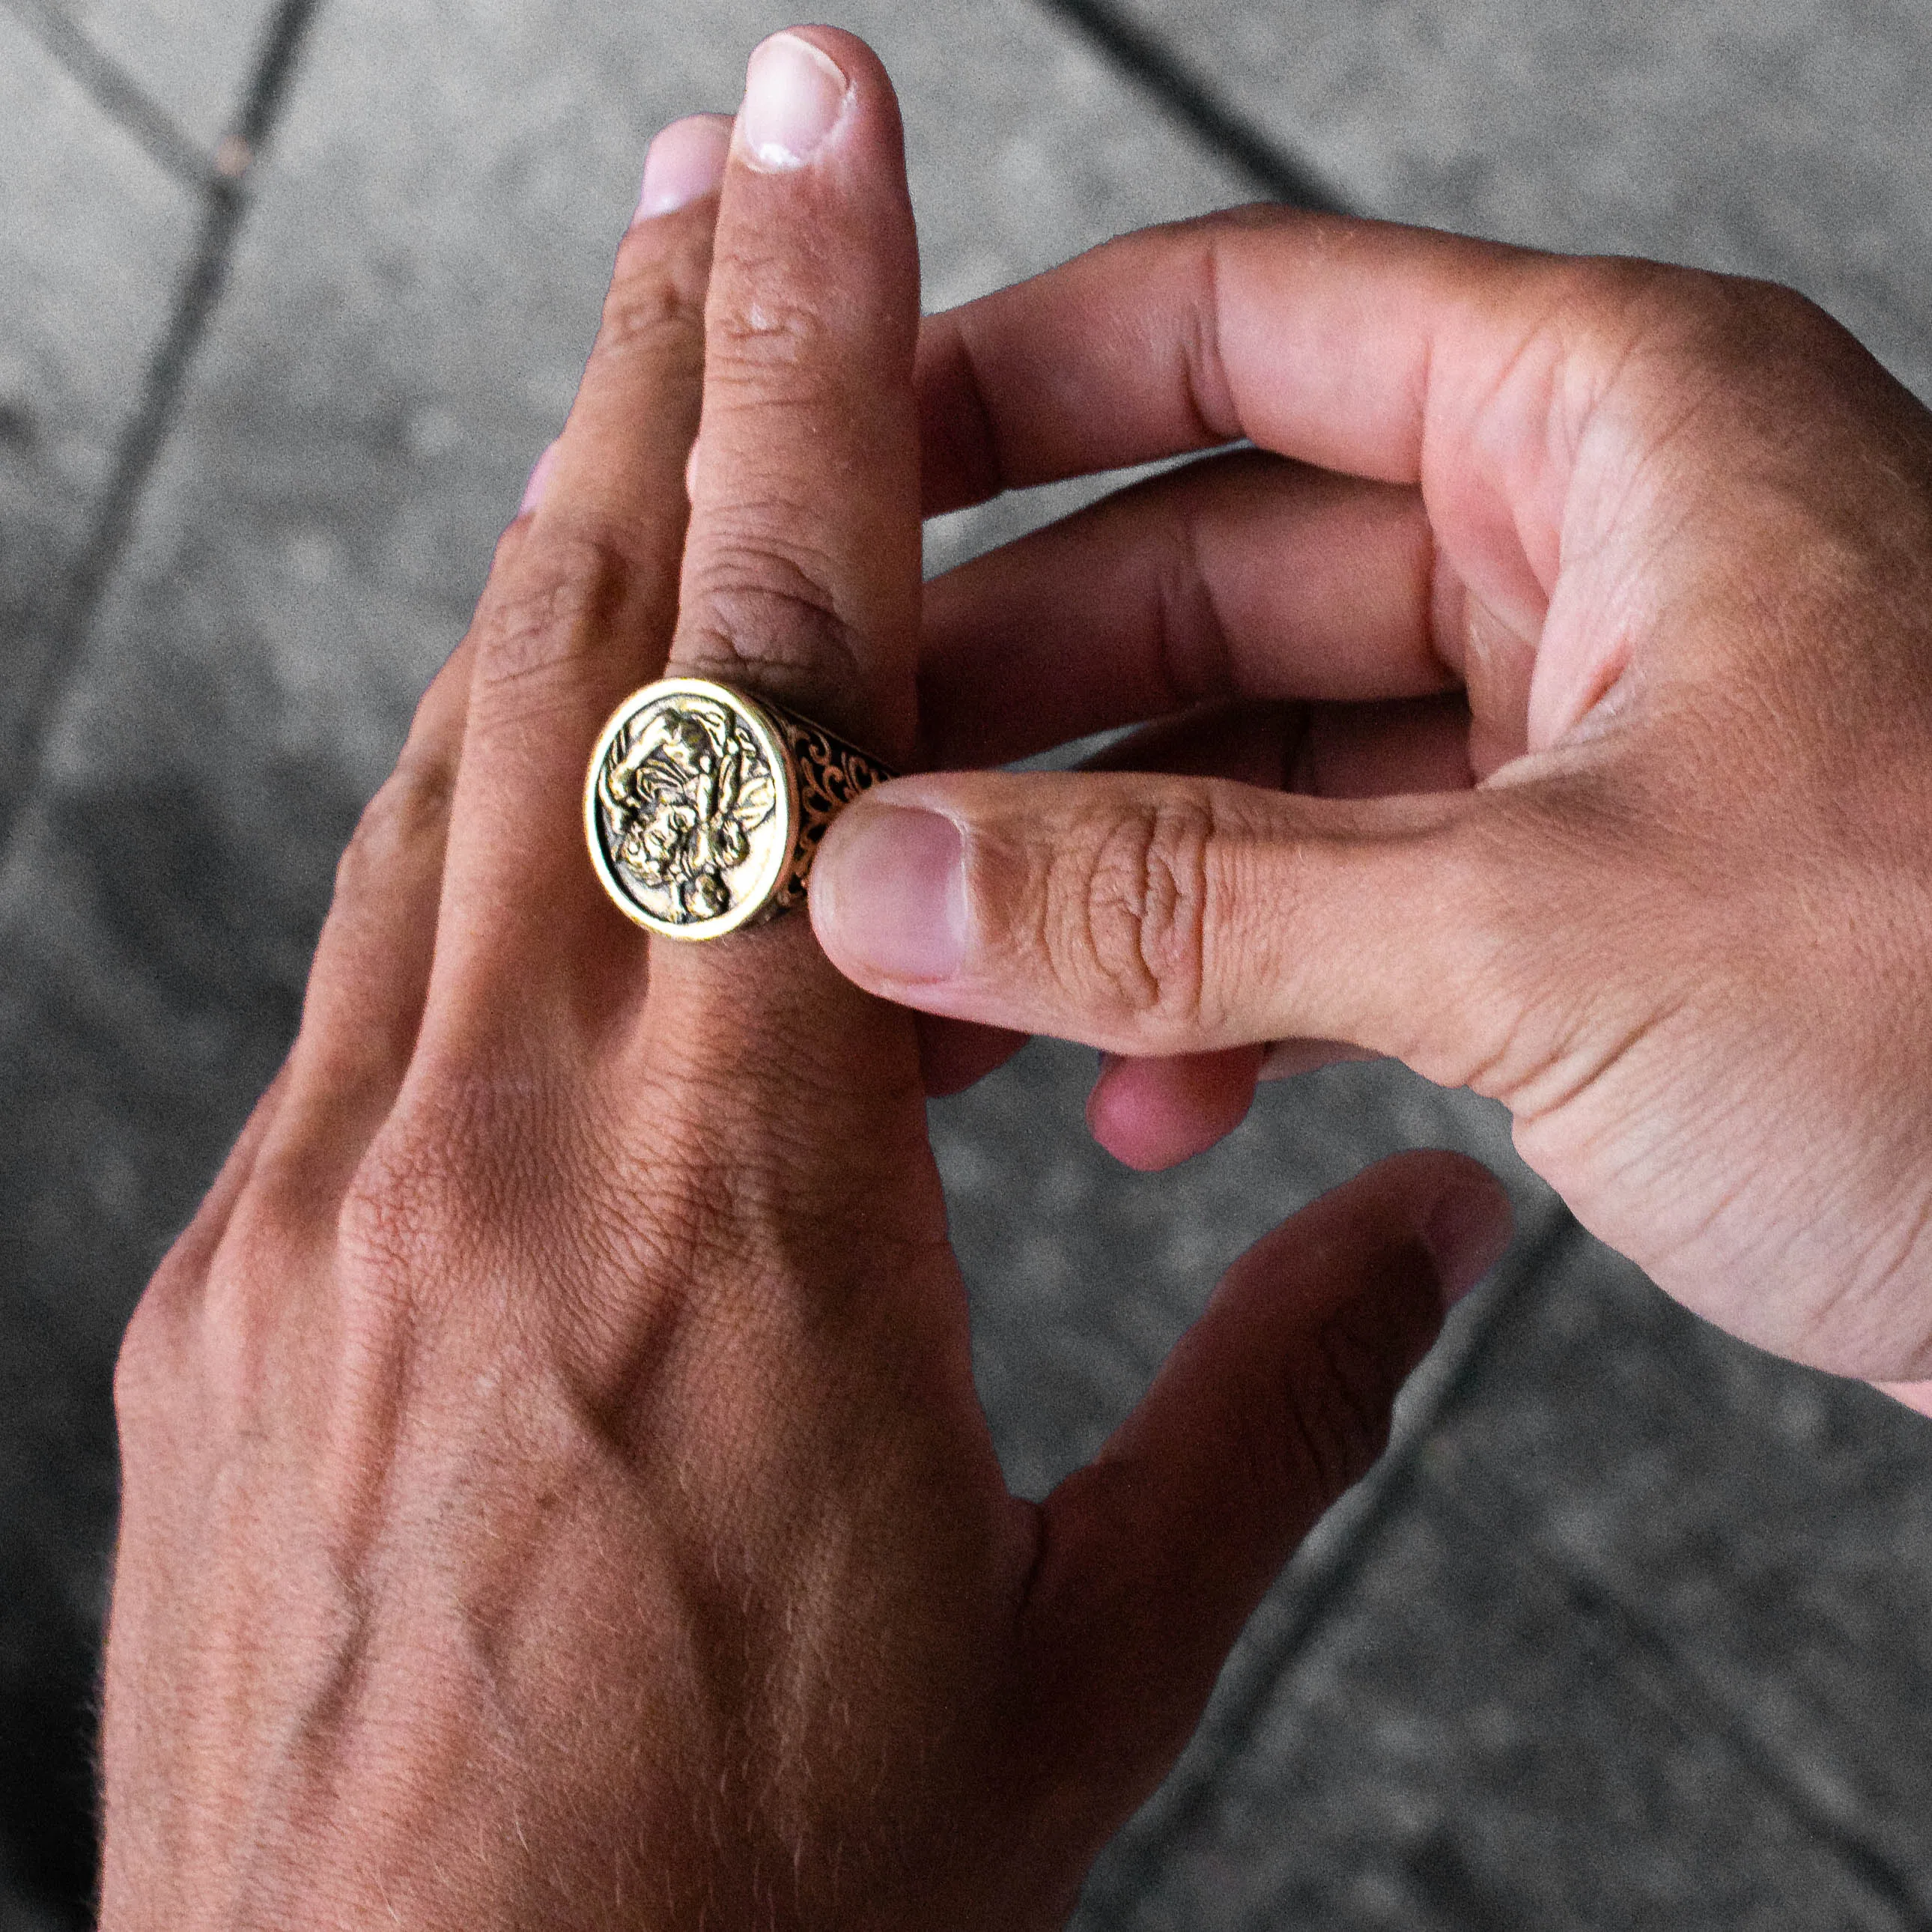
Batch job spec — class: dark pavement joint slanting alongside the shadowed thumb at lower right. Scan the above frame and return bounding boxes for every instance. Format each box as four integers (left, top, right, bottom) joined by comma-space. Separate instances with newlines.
1080, 1200, 1591, 1909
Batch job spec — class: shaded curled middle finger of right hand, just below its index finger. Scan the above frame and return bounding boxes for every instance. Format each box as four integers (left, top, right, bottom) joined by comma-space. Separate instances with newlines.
920, 452, 1455, 765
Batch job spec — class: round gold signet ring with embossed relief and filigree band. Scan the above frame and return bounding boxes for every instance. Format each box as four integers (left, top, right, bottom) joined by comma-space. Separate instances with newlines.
583, 678, 893, 939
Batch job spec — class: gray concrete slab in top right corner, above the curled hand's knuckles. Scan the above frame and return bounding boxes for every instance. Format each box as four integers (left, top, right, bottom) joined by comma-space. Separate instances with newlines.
1125, 0, 1932, 396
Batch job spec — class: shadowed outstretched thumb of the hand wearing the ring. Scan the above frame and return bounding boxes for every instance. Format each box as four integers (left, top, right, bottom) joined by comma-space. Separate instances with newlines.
1028, 1153, 1509, 1806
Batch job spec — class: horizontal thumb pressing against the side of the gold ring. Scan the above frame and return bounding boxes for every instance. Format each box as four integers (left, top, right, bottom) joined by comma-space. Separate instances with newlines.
809, 773, 1511, 1086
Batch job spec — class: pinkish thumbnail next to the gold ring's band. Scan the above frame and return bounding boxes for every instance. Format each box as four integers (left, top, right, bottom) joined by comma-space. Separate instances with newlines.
812, 806, 966, 979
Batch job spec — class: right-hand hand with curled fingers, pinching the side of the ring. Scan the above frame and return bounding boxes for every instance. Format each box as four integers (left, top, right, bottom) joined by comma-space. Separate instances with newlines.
812, 210, 1932, 1379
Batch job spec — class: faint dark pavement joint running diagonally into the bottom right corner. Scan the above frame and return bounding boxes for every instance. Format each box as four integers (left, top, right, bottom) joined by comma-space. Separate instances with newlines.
1442, 1465, 1932, 1932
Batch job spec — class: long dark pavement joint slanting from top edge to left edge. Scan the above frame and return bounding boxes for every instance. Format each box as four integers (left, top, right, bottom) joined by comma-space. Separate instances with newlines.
0, 0, 321, 858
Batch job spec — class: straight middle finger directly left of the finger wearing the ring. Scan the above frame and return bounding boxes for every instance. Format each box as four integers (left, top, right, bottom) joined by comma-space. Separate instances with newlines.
435, 116, 725, 1030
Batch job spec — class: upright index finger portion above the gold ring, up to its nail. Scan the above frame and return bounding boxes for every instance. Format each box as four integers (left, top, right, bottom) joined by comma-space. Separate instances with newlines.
672, 27, 920, 763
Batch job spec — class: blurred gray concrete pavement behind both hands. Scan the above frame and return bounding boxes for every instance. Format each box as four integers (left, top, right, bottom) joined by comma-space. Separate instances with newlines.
0, 0, 1932, 1932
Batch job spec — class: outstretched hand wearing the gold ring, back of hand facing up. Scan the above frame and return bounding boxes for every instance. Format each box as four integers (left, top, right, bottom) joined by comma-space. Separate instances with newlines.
103, 29, 1507, 1932
